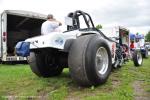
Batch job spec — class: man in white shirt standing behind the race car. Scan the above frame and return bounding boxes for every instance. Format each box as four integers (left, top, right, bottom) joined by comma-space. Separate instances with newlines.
41, 14, 62, 35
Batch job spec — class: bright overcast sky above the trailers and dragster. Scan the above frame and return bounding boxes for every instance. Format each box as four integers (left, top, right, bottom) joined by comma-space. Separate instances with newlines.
0, 0, 150, 34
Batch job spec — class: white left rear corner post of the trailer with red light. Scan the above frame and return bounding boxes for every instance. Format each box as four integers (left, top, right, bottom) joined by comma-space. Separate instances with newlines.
1, 12, 7, 61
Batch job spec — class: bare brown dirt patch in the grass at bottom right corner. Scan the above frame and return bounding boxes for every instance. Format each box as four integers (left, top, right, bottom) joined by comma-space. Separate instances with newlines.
133, 81, 150, 100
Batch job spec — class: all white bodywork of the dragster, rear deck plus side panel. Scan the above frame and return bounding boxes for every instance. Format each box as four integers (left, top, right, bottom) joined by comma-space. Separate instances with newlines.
25, 30, 116, 63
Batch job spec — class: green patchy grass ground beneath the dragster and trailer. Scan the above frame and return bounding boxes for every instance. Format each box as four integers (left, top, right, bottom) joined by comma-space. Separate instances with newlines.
0, 58, 150, 100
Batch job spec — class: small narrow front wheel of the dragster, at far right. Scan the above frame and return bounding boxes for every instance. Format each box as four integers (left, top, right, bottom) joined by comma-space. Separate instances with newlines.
133, 50, 143, 66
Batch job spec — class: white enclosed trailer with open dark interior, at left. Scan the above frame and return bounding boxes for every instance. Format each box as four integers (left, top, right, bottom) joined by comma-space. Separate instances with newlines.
0, 10, 46, 62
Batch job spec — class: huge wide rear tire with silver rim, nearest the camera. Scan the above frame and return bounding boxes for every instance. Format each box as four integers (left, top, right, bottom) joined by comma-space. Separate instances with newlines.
68, 34, 112, 86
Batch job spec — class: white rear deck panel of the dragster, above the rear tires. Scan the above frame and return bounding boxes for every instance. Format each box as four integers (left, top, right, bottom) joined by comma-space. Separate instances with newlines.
26, 31, 79, 49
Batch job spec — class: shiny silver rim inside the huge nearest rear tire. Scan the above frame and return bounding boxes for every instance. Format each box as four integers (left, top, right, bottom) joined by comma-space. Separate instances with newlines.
95, 47, 109, 75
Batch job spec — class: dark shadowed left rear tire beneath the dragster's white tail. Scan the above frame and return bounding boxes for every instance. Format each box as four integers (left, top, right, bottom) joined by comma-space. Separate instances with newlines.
29, 52, 63, 77
